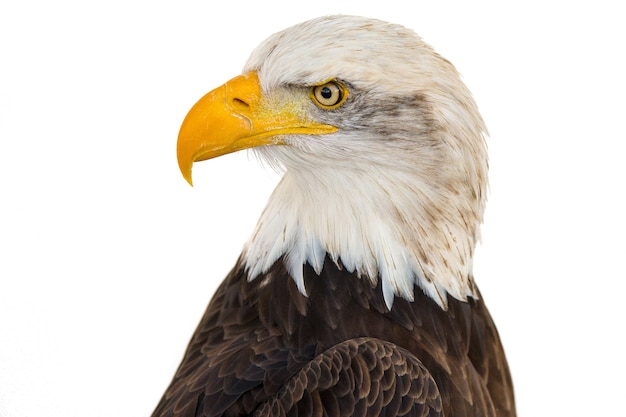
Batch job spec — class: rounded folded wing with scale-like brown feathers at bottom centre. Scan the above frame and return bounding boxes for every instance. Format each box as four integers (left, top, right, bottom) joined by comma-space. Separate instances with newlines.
254, 338, 443, 417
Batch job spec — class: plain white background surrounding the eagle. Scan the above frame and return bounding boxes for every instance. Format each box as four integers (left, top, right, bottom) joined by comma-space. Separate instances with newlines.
0, 0, 626, 417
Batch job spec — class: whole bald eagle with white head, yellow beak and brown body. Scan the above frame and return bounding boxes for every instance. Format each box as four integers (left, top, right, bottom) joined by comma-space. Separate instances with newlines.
153, 16, 515, 417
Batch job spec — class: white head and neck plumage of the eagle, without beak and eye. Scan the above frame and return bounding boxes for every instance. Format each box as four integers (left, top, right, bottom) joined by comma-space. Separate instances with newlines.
236, 16, 487, 308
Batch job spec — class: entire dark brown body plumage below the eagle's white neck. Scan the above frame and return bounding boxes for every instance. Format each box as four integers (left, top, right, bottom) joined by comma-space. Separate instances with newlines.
153, 254, 515, 417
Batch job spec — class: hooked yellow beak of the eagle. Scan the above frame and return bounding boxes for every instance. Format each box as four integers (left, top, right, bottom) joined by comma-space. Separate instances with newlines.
176, 72, 337, 185
